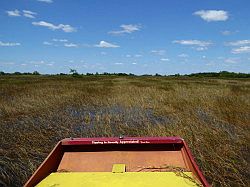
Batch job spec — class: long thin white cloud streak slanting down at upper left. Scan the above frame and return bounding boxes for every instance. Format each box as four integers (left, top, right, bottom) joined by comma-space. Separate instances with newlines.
32, 21, 77, 32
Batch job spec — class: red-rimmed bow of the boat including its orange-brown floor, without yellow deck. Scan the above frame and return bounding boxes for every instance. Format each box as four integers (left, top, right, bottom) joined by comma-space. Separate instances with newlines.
25, 137, 209, 187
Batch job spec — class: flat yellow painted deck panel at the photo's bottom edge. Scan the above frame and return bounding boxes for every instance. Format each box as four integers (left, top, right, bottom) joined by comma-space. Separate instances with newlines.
37, 172, 197, 187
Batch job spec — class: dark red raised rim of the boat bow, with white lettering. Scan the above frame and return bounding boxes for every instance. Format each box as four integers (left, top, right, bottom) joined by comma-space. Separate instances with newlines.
25, 137, 210, 187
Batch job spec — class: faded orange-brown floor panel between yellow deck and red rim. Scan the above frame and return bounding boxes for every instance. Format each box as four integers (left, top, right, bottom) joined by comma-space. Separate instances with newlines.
58, 151, 190, 172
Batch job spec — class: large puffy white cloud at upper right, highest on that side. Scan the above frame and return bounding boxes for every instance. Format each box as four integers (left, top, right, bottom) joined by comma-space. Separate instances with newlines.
194, 10, 229, 22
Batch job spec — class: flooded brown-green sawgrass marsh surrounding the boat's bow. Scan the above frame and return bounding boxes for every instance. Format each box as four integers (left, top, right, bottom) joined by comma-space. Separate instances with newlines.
0, 76, 250, 186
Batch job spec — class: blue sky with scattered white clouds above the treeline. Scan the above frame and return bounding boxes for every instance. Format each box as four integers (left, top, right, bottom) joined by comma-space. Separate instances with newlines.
0, 0, 250, 74
